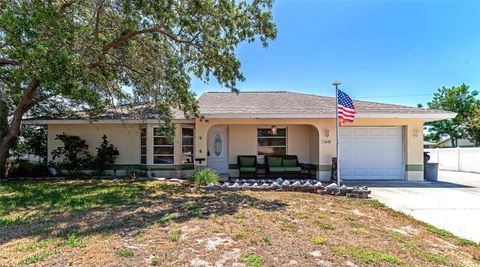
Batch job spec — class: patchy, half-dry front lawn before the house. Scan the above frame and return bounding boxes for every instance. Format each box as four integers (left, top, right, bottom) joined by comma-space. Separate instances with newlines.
0, 180, 480, 266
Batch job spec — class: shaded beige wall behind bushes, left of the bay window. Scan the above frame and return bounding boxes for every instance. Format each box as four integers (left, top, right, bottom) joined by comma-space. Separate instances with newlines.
48, 123, 140, 164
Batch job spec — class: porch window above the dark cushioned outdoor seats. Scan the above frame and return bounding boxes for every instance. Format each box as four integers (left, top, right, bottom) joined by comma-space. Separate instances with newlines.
257, 128, 287, 155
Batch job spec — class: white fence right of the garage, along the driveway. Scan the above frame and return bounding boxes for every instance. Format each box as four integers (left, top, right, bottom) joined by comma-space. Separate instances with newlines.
425, 147, 480, 173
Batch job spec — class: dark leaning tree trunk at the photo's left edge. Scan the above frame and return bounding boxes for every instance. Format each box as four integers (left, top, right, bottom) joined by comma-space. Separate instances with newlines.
0, 78, 40, 179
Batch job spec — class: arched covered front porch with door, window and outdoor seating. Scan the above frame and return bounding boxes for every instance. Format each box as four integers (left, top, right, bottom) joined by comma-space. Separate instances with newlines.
195, 118, 335, 181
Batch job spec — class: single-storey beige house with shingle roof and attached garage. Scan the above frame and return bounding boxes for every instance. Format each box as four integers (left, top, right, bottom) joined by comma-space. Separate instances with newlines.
28, 92, 455, 181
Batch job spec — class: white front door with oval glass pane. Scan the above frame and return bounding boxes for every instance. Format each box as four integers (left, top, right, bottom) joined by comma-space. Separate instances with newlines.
207, 126, 228, 173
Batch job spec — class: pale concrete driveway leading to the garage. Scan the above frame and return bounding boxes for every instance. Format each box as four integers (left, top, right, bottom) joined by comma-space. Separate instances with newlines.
346, 171, 480, 242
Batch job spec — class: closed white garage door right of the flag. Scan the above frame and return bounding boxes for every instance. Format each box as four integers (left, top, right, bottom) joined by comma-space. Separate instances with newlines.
339, 127, 404, 180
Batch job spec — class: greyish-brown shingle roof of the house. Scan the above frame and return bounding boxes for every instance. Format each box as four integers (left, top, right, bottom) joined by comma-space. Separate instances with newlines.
198, 91, 455, 117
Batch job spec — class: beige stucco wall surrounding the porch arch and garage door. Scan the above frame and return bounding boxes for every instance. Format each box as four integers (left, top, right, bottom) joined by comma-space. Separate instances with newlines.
195, 118, 424, 181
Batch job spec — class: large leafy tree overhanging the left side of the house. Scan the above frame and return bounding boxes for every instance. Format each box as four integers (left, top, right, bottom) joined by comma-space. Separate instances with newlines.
0, 0, 276, 177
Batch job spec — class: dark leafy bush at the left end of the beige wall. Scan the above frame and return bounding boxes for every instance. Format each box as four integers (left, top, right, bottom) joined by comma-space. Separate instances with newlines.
52, 133, 92, 175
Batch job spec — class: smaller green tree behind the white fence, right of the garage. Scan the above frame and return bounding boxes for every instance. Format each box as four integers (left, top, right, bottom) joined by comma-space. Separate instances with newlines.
427, 84, 479, 147
